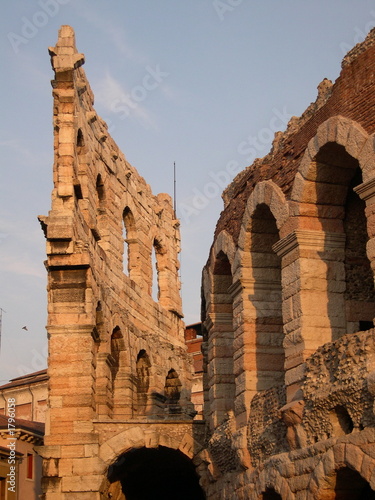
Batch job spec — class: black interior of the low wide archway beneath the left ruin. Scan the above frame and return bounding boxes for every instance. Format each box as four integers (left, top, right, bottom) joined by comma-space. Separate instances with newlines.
108, 446, 205, 500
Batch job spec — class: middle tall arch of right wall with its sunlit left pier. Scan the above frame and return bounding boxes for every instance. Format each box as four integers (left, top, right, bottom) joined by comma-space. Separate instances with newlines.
233, 181, 289, 421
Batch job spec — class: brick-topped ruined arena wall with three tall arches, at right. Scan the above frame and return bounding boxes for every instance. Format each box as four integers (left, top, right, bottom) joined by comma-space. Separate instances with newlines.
201, 30, 375, 500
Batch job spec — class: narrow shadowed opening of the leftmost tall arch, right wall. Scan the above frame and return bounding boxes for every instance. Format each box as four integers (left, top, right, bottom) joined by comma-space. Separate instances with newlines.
208, 251, 236, 426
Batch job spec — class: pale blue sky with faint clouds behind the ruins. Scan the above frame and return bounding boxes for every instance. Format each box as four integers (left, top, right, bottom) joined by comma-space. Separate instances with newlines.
0, 0, 375, 383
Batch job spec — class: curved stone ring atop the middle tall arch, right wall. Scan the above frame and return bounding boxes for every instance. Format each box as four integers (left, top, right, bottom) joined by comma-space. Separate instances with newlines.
238, 180, 289, 254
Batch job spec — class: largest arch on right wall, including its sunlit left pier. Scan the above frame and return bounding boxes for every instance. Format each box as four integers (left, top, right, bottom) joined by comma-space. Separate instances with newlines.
275, 116, 375, 397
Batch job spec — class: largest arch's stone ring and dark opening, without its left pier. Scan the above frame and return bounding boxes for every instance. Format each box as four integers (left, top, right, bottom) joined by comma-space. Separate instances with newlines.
291, 116, 375, 330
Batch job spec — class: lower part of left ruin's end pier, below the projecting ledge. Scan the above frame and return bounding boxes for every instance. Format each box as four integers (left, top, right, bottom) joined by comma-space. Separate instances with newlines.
41, 324, 102, 500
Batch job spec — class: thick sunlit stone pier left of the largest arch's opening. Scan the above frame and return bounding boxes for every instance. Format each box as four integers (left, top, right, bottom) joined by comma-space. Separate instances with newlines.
273, 230, 346, 402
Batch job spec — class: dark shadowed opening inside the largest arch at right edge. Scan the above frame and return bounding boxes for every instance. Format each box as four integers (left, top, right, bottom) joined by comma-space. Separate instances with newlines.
311, 142, 375, 341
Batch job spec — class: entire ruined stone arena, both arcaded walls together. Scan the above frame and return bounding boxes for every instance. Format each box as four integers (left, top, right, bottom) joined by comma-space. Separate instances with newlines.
38, 26, 375, 500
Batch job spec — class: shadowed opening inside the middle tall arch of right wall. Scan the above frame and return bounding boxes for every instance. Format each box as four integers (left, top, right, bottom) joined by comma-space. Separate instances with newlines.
249, 204, 285, 391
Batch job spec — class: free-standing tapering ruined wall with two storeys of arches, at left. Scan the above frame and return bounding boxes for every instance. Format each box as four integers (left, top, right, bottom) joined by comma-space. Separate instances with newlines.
40, 26, 201, 500
